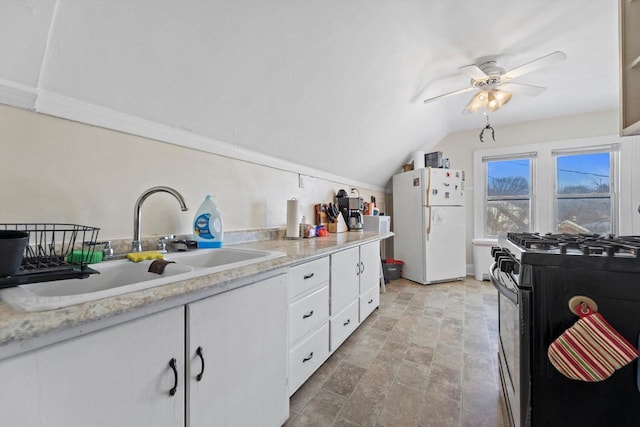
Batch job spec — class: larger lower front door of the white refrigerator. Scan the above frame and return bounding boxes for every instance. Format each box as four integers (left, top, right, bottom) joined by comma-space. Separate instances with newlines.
424, 206, 467, 283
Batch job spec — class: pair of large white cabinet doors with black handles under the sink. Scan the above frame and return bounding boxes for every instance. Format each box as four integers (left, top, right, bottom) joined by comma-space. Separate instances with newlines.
0, 275, 289, 427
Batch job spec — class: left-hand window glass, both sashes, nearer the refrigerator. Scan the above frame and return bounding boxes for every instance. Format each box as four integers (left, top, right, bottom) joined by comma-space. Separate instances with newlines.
482, 154, 533, 236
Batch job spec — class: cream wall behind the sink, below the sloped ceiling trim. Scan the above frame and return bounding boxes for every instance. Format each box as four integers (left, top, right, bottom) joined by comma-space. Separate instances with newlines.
0, 105, 385, 244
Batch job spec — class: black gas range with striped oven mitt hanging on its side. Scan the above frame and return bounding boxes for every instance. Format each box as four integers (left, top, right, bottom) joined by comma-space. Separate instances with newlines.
490, 233, 640, 427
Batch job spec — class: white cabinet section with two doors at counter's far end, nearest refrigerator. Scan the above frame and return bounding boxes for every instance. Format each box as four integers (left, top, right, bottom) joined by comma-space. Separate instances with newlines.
330, 241, 380, 352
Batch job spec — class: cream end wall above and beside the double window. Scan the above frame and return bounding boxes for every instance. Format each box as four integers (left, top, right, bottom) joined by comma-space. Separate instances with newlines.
433, 110, 640, 264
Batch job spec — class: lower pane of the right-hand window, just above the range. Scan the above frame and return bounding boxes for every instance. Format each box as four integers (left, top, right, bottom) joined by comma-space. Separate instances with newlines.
556, 198, 612, 234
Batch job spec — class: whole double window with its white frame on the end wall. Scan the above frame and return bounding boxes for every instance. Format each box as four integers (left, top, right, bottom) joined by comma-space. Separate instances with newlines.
470, 135, 624, 238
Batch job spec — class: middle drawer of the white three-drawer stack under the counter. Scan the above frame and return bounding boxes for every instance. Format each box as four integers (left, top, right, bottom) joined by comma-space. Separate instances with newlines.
289, 285, 329, 345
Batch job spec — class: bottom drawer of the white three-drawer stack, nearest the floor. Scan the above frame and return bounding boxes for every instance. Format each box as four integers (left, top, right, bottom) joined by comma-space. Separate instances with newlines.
289, 322, 329, 395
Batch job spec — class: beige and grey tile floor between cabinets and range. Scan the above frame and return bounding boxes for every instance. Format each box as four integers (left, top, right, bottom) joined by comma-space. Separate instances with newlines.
285, 277, 506, 427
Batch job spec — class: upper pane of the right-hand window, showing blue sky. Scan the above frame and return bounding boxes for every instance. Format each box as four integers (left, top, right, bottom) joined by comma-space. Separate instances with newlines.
556, 153, 611, 194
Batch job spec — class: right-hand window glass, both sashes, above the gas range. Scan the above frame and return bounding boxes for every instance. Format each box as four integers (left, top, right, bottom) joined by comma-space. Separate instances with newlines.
553, 148, 614, 234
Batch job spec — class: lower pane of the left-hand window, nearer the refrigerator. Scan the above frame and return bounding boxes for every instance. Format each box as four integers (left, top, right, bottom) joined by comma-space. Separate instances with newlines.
485, 200, 531, 236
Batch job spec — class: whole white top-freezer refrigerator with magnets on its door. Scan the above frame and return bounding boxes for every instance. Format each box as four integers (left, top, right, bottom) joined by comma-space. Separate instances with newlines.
392, 168, 467, 285
